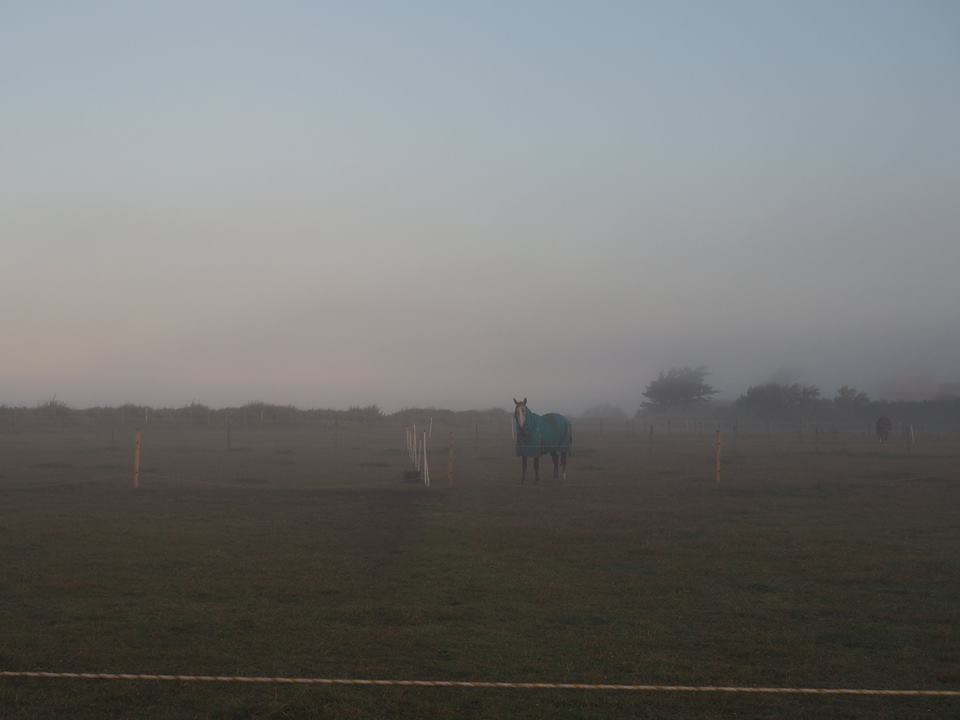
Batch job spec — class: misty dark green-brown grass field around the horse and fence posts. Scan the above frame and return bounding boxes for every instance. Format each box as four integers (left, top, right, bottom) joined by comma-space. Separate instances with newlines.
0, 420, 960, 719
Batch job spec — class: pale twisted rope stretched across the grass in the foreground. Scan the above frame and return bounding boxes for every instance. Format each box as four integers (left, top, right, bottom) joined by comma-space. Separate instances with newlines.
0, 670, 960, 698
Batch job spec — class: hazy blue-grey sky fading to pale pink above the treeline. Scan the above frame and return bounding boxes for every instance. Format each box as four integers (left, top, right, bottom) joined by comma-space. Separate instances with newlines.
0, 0, 960, 412
